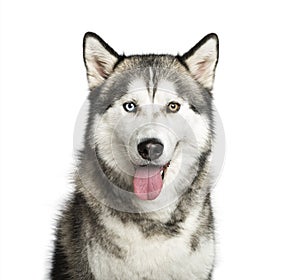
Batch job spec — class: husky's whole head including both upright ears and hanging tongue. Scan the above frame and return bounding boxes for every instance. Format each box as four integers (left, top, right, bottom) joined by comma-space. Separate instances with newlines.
84, 33, 218, 200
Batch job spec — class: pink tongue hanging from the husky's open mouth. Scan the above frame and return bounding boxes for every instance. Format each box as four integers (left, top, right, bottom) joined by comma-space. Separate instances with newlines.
133, 166, 162, 200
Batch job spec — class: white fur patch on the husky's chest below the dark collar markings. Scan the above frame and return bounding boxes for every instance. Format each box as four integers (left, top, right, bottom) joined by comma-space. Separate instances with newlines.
88, 213, 214, 280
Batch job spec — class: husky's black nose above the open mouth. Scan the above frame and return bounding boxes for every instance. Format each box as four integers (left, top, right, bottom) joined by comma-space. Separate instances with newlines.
138, 138, 164, 160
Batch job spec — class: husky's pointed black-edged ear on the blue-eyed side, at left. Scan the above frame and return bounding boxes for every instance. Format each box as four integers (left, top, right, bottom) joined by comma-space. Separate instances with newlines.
83, 32, 119, 90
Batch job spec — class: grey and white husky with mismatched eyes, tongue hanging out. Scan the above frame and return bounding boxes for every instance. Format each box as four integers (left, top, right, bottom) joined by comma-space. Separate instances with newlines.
50, 32, 219, 280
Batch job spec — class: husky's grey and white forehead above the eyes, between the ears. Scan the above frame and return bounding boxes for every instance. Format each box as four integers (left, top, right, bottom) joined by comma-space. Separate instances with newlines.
90, 56, 211, 117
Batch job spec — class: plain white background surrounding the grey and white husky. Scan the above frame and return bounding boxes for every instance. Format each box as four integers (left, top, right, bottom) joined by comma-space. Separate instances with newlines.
0, 0, 300, 280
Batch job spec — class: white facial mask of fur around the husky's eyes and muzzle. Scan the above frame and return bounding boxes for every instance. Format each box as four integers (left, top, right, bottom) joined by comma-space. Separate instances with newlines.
93, 75, 210, 213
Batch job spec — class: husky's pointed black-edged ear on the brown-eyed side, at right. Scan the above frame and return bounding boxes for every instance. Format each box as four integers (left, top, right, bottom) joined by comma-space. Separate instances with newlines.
181, 33, 219, 90
